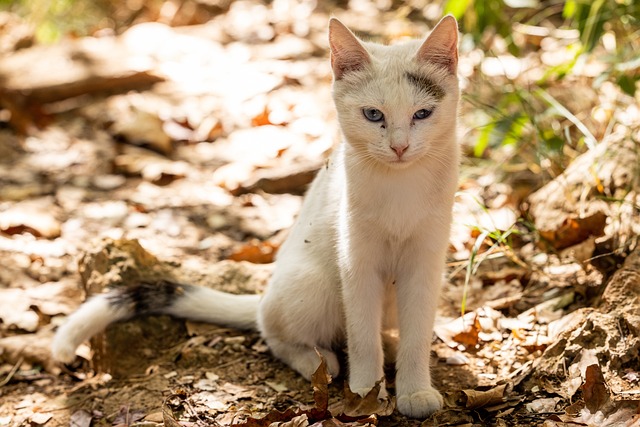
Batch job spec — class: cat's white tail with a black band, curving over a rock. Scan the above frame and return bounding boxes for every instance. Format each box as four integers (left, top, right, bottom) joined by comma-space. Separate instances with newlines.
52, 281, 261, 363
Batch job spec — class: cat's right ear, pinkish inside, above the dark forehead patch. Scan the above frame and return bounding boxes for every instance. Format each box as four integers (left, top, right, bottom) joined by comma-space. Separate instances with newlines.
416, 15, 458, 74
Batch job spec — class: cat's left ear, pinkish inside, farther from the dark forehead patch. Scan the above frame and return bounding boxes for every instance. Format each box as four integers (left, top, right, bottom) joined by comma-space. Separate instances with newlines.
329, 18, 371, 80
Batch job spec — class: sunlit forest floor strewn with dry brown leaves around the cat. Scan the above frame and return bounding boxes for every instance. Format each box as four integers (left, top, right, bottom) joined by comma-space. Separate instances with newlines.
0, 0, 640, 427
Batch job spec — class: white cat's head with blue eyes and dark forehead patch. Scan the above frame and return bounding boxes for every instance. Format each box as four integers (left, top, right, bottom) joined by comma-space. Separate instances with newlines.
329, 16, 459, 168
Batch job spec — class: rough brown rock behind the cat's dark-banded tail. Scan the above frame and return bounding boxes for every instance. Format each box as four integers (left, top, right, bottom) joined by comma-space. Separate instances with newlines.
74, 239, 271, 378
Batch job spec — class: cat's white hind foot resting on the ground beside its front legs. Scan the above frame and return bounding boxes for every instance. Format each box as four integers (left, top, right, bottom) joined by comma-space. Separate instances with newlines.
265, 338, 340, 380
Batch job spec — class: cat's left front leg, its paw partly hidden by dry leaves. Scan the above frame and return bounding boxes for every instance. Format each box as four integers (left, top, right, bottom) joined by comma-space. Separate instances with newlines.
341, 242, 386, 396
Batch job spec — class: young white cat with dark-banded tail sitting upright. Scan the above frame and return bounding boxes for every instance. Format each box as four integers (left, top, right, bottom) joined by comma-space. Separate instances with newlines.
53, 15, 459, 418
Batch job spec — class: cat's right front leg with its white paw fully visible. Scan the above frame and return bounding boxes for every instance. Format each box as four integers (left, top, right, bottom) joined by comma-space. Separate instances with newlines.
396, 247, 444, 418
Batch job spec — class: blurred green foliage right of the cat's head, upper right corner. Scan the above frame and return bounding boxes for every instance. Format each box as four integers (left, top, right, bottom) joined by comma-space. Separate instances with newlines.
444, 0, 640, 172
